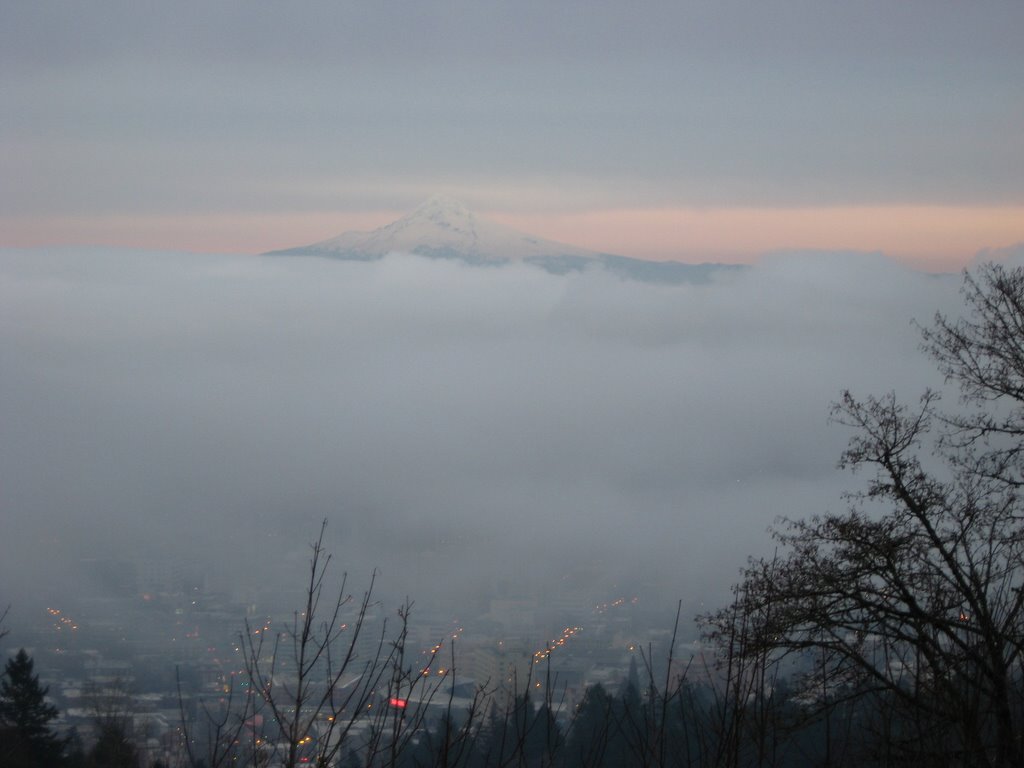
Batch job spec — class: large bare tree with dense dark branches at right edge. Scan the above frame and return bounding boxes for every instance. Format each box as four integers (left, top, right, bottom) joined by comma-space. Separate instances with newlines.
711, 265, 1024, 766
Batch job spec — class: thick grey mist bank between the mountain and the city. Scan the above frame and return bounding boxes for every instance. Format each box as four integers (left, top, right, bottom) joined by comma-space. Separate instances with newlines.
0, 248, 959, 622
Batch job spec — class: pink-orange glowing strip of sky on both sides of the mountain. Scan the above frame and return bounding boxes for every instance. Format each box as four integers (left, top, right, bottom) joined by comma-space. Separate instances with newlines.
0, 206, 1024, 270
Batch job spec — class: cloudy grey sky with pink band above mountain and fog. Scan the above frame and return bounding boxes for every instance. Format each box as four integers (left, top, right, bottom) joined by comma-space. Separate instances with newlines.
6, 0, 1024, 271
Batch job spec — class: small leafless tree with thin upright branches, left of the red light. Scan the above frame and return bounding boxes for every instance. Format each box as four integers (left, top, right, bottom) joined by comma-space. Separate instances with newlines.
178, 520, 482, 768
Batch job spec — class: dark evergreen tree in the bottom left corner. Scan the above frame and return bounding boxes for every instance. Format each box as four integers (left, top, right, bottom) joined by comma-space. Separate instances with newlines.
0, 648, 66, 768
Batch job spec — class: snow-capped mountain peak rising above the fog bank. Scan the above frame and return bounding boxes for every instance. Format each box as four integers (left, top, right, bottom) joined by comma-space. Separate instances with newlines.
264, 197, 732, 283
